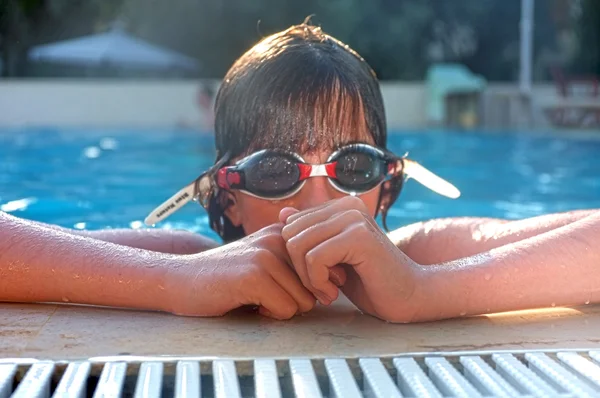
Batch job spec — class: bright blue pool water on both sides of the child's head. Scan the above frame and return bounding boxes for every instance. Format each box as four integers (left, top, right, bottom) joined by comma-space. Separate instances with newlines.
0, 129, 600, 237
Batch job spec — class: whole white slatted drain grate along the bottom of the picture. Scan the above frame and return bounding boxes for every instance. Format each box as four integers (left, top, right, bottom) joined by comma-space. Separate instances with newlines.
0, 350, 600, 398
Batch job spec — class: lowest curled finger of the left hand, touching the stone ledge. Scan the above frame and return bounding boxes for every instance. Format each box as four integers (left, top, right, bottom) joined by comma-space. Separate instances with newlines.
244, 278, 298, 319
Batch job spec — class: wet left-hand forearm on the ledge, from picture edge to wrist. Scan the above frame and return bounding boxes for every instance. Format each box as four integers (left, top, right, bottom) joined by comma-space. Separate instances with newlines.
0, 212, 177, 310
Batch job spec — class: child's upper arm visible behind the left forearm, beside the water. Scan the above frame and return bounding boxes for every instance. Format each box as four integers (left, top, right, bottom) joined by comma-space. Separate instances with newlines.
17, 216, 219, 254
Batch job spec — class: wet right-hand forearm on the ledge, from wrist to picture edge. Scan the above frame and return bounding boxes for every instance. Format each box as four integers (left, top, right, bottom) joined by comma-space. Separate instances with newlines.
418, 213, 600, 320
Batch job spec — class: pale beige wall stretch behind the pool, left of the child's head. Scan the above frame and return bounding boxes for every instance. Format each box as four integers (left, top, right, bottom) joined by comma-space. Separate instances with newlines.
0, 80, 204, 127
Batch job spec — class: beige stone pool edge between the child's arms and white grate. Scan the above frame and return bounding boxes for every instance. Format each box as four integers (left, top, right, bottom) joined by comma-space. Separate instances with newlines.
0, 300, 600, 362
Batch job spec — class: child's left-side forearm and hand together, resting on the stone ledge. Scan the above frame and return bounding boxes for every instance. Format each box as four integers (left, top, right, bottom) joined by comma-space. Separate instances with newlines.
0, 212, 315, 318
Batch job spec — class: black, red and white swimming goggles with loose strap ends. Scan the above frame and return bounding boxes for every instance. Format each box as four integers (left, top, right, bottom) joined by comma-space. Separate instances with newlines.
145, 144, 460, 225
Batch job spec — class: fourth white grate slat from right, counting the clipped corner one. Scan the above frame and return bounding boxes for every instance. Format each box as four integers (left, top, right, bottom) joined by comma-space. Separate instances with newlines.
492, 354, 559, 397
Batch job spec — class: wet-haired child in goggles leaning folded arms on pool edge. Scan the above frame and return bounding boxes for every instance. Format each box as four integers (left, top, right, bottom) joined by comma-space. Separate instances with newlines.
0, 23, 600, 322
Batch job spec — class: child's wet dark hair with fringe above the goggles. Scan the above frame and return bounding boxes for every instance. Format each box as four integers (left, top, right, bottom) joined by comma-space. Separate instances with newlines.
209, 20, 399, 242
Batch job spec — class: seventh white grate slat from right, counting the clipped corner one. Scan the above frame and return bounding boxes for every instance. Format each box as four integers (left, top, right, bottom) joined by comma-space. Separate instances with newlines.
394, 358, 442, 398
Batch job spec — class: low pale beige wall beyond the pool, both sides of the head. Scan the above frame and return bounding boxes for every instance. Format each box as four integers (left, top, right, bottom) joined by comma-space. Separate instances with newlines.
0, 80, 555, 130
